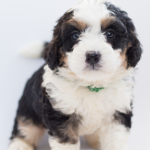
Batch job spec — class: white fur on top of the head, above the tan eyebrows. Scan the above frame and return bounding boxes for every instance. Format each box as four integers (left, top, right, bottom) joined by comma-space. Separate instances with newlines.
72, 0, 110, 27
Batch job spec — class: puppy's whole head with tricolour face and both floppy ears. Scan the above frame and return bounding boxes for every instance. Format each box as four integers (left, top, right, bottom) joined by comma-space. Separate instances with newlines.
44, 0, 142, 81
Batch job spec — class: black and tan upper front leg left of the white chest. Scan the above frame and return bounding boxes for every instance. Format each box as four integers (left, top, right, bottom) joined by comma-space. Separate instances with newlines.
42, 89, 81, 144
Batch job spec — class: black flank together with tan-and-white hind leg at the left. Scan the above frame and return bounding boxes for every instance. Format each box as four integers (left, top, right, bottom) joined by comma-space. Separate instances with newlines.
9, 67, 44, 150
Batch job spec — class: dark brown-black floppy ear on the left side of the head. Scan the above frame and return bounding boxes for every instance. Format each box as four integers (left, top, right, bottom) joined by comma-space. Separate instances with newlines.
43, 11, 73, 70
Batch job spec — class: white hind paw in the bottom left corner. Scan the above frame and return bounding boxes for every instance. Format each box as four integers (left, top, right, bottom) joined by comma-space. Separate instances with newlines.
8, 139, 34, 150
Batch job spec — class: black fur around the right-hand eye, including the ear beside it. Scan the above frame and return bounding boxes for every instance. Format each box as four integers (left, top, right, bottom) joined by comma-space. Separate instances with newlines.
103, 3, 142, 67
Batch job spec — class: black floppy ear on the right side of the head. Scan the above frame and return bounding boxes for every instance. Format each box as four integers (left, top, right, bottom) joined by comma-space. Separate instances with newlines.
106, 3, 142, 67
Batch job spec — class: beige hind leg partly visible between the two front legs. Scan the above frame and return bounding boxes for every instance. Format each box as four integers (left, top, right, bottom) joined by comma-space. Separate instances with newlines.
84, 130, 100, 150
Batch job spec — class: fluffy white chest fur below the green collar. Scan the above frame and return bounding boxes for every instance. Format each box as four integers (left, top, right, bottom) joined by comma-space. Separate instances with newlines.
42, 66, 133, 135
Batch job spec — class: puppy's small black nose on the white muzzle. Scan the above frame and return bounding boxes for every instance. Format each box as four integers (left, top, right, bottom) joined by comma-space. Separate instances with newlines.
86, 51, 101, 65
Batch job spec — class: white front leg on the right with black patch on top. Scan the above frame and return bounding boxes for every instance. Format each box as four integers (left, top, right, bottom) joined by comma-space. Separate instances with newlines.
100, 113, 131, 150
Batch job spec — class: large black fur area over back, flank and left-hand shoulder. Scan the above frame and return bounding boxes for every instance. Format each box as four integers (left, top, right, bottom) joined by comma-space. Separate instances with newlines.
11, 66, 81, 144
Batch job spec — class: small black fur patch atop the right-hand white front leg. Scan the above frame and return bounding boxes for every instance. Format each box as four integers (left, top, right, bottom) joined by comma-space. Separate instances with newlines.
114, 111, 133, 129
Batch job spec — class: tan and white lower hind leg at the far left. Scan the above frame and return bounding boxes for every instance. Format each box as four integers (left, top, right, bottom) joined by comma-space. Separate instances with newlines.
9, 118, 45, 150
